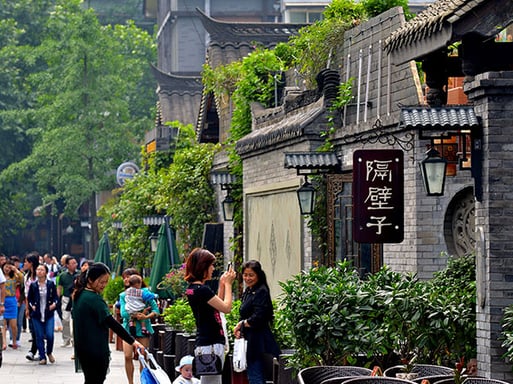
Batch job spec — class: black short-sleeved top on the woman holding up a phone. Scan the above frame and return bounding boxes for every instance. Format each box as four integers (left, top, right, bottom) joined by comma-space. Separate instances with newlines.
185, 284, 225, 347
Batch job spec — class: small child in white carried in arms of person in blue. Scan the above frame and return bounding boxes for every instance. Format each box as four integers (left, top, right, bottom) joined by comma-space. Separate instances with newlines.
125, 275, 157, 337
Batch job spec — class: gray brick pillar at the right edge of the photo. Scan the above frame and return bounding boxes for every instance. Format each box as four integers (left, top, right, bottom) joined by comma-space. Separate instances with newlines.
465, 71, 513, 382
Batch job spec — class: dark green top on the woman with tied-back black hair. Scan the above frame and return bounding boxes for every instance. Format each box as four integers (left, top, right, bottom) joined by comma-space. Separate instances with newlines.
72, 290, 111, 359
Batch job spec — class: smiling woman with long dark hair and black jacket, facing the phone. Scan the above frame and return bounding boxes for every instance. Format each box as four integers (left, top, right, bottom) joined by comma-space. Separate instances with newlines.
234, 260, 280, 384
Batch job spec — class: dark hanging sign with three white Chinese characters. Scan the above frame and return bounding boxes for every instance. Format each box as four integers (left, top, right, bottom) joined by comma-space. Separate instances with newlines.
353, 149, 404, 243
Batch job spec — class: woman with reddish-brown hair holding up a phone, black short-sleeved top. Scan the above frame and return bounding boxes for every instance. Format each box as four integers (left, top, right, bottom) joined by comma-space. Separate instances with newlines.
185, 248, 236, 384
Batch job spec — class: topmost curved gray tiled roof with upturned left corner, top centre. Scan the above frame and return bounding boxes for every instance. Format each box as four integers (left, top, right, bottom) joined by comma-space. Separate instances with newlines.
196, 8, 308, 42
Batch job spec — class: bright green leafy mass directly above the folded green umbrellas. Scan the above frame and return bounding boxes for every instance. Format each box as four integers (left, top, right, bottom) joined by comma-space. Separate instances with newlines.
99, 122, 218, 267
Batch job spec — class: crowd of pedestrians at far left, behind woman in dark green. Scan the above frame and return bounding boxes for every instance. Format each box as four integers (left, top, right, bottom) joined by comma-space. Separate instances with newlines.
0, 252, 83, 365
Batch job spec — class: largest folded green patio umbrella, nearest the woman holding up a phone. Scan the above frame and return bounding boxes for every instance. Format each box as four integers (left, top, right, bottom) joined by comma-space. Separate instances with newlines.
150, 221, 178, 299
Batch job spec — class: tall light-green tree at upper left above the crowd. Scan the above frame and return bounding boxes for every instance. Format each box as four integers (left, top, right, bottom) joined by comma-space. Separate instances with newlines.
2, 0, 155, 254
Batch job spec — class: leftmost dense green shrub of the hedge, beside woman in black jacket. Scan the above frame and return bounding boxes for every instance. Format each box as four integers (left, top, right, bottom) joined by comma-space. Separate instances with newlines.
281, 263, 368, 366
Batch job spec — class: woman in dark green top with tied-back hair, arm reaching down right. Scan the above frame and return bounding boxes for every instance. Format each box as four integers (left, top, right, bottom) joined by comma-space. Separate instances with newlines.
72, 263, 144, 384
